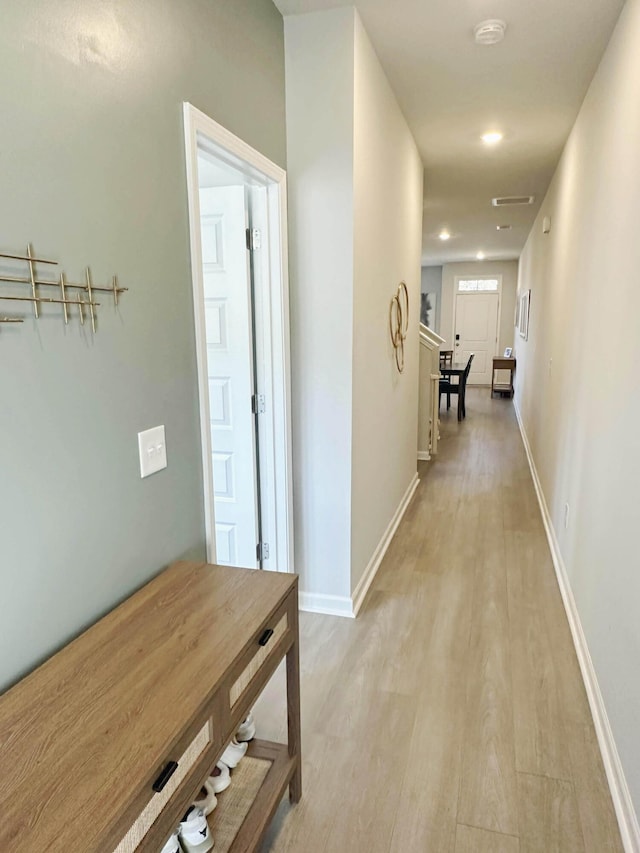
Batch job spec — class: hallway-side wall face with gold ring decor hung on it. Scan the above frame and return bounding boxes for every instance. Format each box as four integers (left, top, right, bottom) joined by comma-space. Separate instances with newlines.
351, 13, 423, 591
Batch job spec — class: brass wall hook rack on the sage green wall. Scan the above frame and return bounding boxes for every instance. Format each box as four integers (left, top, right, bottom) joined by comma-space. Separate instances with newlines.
0, 244, 129, 333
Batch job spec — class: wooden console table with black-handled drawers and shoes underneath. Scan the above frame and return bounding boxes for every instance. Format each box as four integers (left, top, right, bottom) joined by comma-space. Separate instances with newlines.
0, 563, 301, 853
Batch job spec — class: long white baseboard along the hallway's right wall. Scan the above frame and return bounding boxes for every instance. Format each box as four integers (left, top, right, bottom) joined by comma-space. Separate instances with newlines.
513, 399, 640, 853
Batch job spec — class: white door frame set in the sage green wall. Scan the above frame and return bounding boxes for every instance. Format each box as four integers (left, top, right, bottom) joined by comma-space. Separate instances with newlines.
183, 102, 293, 572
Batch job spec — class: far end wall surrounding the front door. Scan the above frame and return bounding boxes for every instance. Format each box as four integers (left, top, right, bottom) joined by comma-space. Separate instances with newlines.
440, 261, 518, 355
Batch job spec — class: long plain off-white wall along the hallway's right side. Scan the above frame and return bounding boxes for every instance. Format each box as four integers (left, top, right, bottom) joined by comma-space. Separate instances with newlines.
516, 0, 640, 824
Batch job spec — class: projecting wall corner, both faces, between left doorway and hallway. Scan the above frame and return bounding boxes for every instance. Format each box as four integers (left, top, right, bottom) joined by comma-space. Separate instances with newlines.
285, 7, 422, 612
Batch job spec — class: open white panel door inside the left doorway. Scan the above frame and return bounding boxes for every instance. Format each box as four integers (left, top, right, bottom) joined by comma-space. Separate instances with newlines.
200, 186, 258, 568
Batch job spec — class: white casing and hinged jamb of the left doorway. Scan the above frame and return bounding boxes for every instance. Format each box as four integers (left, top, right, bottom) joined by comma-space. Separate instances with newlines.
183, 103, 294, 572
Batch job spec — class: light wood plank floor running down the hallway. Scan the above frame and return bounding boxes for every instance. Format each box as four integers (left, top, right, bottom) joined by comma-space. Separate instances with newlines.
255, 388, 622, 853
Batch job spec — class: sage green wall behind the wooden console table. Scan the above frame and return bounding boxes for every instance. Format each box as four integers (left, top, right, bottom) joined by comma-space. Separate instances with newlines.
0, 0, 285, 687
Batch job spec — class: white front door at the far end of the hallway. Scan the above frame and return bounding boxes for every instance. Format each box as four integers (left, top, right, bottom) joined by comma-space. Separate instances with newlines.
454, 293, 500, 385
